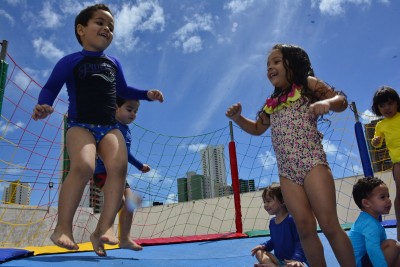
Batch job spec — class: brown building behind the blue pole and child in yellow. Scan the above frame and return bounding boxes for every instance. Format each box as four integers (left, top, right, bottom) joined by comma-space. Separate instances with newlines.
364, 120, 393, 172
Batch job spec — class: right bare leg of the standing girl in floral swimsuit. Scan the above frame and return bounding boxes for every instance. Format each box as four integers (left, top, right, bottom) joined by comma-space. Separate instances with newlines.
304, 165, 356, 267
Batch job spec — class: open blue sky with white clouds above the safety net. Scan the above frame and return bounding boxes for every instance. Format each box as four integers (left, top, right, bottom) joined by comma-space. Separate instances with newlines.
0, 0, 400, 207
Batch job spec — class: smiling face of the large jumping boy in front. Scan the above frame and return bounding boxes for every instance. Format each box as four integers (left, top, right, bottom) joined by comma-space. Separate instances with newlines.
77, 9, 114, 52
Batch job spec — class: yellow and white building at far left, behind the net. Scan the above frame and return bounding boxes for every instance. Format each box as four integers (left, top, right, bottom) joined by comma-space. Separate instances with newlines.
3, 180, 31, 205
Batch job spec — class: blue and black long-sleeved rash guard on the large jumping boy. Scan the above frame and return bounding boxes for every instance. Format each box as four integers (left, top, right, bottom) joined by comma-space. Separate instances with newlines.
38, 50, 150, 125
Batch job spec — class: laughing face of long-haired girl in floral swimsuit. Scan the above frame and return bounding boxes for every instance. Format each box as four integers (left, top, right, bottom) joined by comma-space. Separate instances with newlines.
267, 49, 290, 89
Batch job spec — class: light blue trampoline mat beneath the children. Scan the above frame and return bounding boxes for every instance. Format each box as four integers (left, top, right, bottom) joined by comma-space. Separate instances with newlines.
1, 228, 396, 267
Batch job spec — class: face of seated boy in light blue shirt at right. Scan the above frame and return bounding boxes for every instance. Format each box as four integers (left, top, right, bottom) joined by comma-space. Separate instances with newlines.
362, 184, 392, 218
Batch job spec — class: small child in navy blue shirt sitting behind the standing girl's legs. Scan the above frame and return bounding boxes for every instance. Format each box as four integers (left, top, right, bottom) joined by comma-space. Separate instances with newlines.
251, 184, 307, 267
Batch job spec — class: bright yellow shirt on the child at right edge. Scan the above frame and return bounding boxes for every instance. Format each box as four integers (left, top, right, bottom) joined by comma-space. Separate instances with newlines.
374, 112, 400, 163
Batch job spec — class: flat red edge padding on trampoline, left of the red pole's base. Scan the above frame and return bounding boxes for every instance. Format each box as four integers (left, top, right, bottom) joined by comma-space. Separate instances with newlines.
135, 233, 248, 246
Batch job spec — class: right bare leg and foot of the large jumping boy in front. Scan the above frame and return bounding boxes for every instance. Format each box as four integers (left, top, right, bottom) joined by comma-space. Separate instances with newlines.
90, 130, 128, 256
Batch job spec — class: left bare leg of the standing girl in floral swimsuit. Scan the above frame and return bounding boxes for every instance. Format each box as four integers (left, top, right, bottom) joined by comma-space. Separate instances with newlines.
280, 177, 326, 267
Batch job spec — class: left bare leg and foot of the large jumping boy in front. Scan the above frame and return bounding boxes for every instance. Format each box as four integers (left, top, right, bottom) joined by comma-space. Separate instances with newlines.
50, 127, 96, 250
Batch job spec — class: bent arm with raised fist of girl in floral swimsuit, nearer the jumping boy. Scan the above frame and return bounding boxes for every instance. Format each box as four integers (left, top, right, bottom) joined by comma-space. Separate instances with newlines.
225, 103, 270, 135
